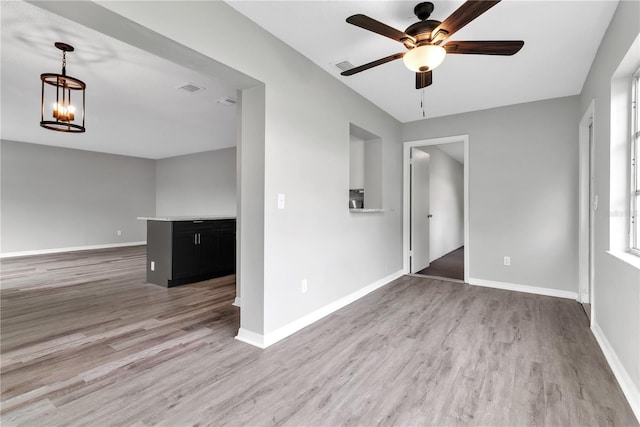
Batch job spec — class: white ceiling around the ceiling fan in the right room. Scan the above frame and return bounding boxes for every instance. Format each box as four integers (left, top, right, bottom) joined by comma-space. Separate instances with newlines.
228, 0, 618, 122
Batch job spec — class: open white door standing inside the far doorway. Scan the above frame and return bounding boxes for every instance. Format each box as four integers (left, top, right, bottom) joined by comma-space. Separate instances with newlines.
409, 148, 429, 273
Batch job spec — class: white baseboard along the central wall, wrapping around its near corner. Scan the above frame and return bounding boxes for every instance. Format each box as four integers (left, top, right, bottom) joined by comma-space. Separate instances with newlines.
236, 270, 403, 348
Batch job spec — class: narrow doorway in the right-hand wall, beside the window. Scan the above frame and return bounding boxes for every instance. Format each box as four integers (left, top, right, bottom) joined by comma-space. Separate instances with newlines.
578, 101, 598, 323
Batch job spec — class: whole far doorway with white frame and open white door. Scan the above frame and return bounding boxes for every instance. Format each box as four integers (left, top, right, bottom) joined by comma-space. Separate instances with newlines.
403, 135, 470, 283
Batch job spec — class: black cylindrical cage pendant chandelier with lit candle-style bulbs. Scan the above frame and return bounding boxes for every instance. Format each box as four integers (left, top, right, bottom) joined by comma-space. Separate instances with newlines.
40, 42, 86, 133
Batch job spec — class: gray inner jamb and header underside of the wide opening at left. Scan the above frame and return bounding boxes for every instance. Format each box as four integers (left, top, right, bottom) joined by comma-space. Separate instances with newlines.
30, 2, 266, 345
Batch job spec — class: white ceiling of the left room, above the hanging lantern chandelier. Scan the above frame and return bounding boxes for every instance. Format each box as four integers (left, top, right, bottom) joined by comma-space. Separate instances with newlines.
0, 0, 236, 159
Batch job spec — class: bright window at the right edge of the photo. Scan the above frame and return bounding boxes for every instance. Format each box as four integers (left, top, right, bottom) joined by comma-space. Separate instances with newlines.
629, 68, 640, 255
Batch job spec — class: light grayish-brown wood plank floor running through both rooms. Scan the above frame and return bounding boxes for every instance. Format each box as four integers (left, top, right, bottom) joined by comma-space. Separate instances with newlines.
0, 247, 637, 427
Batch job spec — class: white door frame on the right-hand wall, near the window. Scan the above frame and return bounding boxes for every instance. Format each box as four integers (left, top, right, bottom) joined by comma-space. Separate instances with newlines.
578, 100, 595, 321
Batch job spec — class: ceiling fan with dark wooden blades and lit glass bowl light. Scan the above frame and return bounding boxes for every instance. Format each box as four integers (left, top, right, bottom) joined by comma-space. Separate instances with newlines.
341, 0, 524, 89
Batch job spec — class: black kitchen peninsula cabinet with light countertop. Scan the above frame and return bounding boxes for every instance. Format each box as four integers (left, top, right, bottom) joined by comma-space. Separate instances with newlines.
138, 216, 236, 287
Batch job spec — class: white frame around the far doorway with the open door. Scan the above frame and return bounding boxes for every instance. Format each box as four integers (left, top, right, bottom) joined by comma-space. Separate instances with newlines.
402, 135, 471, 283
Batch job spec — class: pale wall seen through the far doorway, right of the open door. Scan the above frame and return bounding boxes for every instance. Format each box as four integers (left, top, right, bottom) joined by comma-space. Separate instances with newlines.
420, 146, 464, 262
